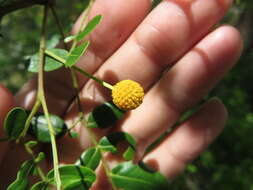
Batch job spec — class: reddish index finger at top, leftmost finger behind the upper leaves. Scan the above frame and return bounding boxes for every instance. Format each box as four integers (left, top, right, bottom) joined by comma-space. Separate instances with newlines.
72, 0, 151, 85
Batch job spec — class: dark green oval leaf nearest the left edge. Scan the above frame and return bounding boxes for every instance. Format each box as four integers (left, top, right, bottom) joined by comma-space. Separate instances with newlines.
4, 107, 27, 140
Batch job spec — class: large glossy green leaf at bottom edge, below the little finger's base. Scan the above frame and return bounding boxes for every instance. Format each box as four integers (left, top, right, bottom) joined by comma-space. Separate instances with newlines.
110, 162, 168, 190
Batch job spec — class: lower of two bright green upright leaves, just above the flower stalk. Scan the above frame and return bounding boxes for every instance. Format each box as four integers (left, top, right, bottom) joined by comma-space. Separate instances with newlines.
65, 41, 90, 67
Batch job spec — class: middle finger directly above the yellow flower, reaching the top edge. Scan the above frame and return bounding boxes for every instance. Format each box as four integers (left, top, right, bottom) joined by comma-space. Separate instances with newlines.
84, 0, 231, 97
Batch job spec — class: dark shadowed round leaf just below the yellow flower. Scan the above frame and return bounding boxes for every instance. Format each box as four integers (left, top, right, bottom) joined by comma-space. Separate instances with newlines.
87, 102, 125, 129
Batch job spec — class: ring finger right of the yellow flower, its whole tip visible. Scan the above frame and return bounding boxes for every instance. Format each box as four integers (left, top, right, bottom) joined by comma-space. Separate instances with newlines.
122, 26, 242, 153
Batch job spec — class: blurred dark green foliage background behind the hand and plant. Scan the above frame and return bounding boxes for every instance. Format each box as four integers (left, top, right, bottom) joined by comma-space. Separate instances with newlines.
0, 0, 253, 190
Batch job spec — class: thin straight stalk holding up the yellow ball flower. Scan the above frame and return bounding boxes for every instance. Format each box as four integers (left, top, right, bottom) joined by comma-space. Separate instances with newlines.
45, 50, 113, 90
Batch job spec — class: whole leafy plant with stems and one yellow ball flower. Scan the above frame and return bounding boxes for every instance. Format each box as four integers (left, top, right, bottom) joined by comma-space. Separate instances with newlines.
2, 0, 168, 190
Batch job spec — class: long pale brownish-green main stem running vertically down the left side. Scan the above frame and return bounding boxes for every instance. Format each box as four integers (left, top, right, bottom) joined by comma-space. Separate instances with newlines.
37, 5, 61, 190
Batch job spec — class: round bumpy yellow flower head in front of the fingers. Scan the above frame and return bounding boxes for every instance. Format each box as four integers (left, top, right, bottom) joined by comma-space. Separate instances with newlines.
112, 80, 144, 110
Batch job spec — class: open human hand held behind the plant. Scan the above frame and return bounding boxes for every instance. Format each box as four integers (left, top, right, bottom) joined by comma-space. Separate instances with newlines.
0, 0, 242, 190
